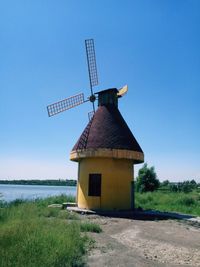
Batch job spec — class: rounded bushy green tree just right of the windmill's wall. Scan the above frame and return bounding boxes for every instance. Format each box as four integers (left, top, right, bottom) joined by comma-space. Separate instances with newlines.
136, 163, 160, 193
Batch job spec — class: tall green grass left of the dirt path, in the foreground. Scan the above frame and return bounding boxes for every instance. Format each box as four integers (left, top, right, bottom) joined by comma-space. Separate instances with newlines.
0, 196, 100, 267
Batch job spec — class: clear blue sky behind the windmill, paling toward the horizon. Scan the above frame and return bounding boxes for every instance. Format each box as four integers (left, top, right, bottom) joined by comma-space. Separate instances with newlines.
0, 0, 200, 182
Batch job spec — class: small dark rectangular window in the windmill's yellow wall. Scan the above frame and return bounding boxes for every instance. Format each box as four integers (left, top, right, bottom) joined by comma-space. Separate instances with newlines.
88, 173, 101, 197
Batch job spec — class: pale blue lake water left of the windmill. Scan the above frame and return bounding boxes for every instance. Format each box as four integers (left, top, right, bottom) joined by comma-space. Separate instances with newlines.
0, 184, 76, 202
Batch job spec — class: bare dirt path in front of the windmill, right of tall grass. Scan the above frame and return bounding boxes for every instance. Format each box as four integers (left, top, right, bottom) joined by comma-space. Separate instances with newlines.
84, 215, 200, 267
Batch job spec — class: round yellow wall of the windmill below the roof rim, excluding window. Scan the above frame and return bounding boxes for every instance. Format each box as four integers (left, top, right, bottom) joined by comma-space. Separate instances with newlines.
77, 158, 133, 210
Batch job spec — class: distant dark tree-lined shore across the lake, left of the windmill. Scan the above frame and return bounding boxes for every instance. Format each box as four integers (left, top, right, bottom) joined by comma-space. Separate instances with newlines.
0, 179, 77, 186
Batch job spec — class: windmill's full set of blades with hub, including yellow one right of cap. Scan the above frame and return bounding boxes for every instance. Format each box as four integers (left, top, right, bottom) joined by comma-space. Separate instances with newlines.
47, 39, 128, 120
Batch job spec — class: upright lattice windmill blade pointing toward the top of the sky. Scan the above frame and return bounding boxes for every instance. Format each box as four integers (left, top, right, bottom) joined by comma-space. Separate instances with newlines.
85, 39, 98, 91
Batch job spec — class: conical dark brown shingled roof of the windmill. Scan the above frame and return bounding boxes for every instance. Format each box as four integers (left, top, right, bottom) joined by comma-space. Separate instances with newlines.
72, 105, 143, 153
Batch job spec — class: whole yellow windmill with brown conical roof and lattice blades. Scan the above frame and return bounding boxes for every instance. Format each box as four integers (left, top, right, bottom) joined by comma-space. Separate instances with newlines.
47, 39, 144, 210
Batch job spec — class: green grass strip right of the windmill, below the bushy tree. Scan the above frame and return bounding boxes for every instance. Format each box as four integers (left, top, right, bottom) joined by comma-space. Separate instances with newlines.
136, 191, 200, 216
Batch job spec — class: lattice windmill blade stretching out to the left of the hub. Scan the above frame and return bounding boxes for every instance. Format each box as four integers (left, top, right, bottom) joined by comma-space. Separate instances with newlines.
47, 93, 89, 117
